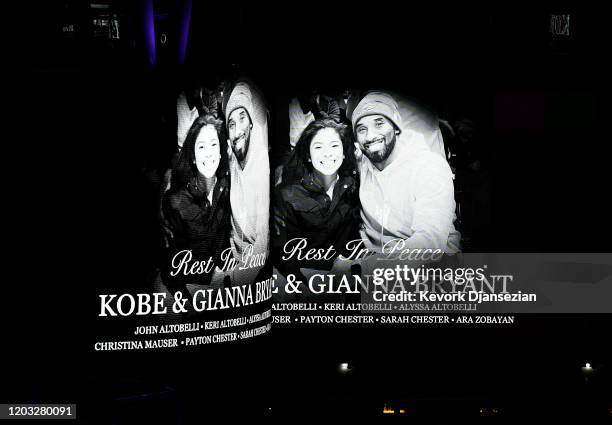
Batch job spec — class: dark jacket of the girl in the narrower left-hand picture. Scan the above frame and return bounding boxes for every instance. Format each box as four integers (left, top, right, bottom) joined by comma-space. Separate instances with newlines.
162, 173, 231, 285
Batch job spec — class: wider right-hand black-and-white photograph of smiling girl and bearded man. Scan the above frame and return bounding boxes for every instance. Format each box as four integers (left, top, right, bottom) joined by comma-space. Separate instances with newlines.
273, 89, 468, 298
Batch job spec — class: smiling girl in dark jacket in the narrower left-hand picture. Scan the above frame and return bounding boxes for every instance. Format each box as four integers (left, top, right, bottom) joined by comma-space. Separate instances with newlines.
162, 115, 231, 284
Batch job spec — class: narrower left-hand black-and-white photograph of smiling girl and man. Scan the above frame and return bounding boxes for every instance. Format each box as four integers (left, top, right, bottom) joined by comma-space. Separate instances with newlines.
149, 71, 270, 318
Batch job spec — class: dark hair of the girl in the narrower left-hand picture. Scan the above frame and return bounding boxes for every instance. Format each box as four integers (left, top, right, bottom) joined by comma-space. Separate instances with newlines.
172, 115, 229, 188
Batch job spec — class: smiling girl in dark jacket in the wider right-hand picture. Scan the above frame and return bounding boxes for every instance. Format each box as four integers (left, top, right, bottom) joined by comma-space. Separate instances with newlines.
273, 119, 359, 282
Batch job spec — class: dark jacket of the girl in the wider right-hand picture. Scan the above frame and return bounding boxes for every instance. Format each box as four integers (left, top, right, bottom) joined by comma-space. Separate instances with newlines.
272, 173, 360, 276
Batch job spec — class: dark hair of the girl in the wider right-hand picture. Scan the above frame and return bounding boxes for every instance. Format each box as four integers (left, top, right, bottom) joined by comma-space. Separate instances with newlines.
283, 118, 357, 182
